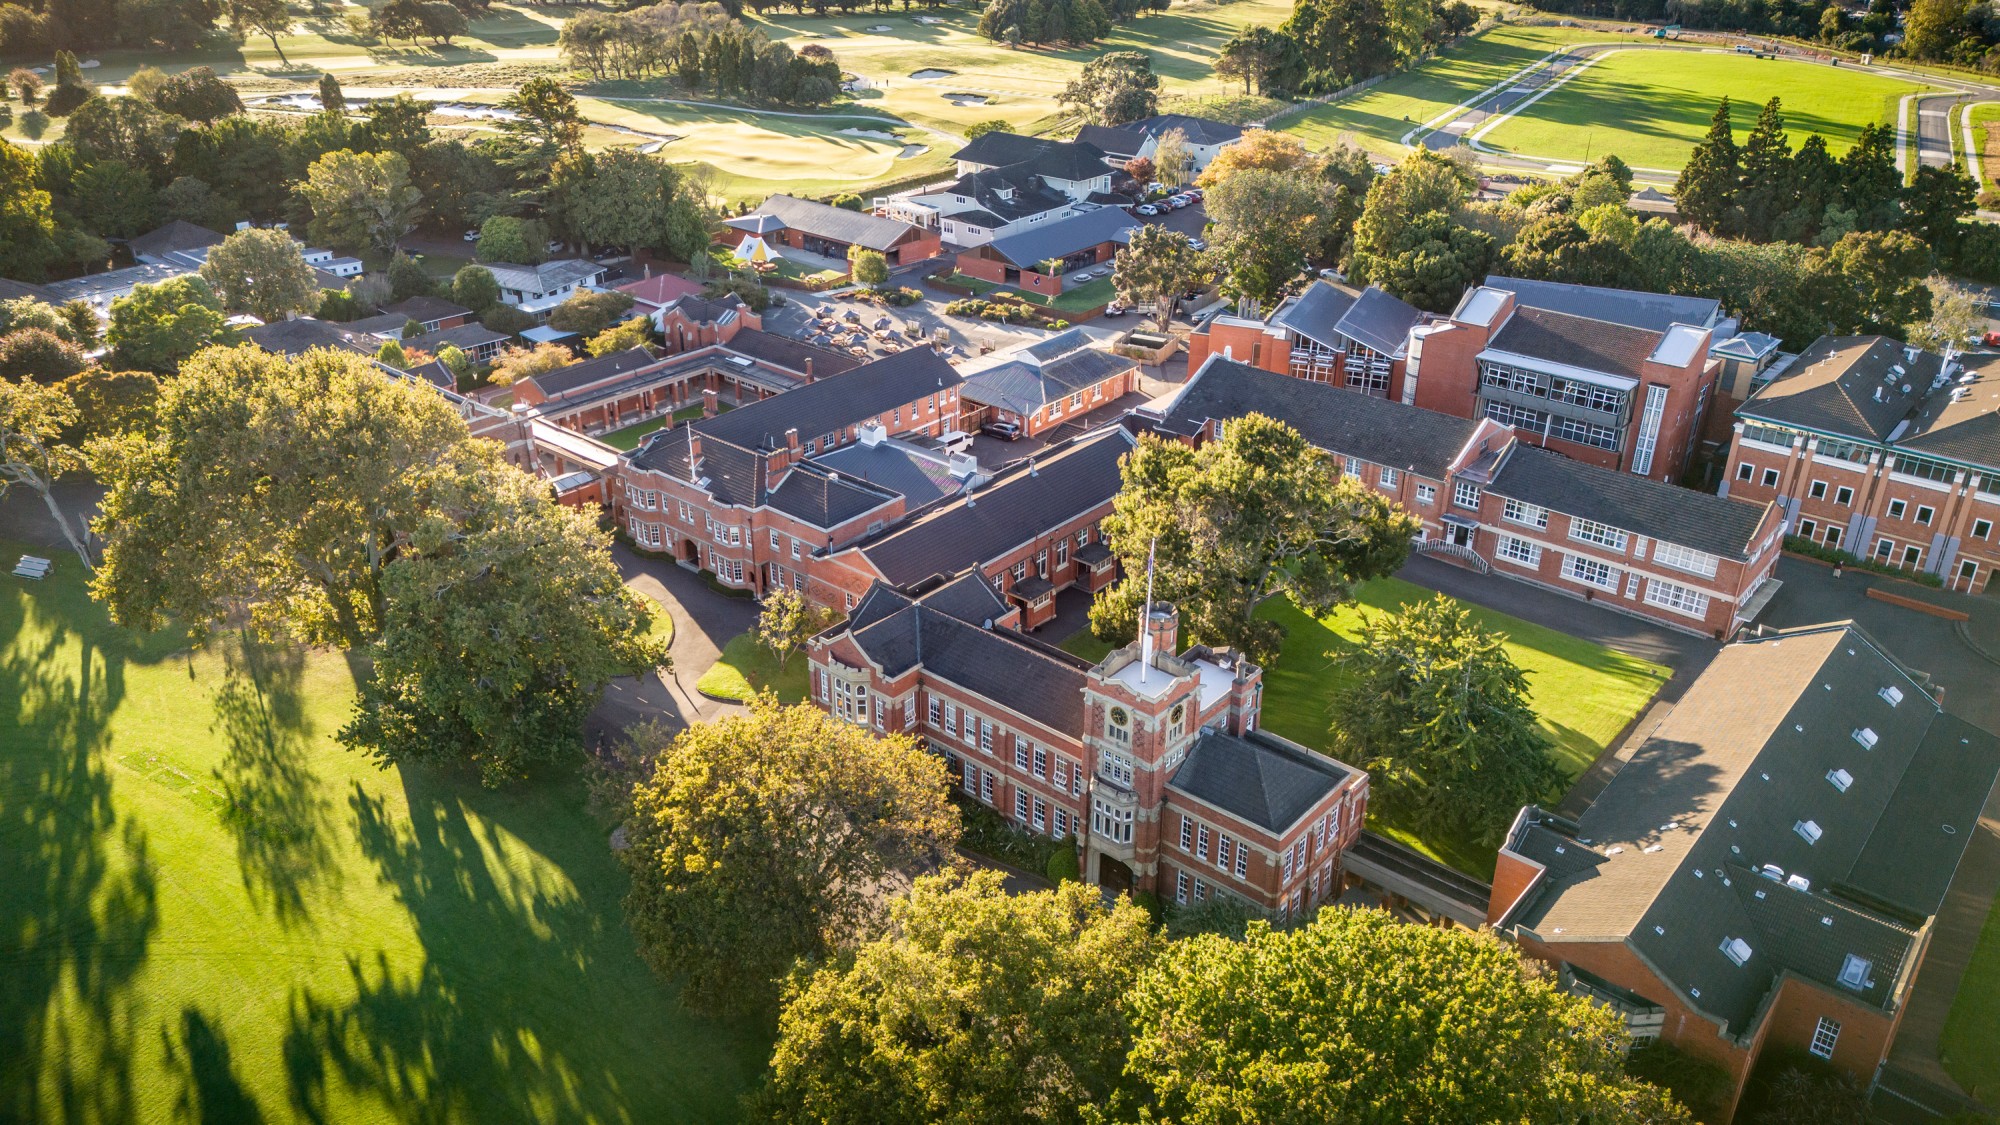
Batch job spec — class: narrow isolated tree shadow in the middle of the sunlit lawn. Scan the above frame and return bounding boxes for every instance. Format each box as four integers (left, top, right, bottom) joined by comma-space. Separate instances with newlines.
214, 637, 340, 927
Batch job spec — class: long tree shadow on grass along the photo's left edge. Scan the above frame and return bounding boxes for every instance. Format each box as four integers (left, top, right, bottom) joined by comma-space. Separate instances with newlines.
0, 571, 158, 1121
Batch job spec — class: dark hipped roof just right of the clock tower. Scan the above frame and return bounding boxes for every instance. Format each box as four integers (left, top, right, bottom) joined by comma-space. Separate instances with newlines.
1168, 731, 1348, 835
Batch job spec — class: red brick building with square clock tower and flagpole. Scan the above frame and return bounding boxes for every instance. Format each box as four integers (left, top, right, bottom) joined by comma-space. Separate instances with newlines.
808, 588, 1368, 919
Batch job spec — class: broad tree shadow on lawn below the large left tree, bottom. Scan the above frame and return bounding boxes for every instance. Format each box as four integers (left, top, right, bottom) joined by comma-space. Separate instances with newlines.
284, 769, 768, 1123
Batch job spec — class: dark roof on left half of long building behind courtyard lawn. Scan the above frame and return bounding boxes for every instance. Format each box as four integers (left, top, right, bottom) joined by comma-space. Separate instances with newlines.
1166, 356, 1478, 480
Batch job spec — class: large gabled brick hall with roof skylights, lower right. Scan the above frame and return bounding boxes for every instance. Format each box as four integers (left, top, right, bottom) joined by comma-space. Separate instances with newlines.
1488, 625, 2000, 1121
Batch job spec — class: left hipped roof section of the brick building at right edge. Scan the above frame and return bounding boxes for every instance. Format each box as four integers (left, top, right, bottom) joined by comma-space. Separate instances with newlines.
1736, 336, 1944, 442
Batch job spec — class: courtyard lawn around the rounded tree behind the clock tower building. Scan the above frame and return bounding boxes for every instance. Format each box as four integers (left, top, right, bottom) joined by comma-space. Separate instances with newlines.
1258, 579, 1668, 879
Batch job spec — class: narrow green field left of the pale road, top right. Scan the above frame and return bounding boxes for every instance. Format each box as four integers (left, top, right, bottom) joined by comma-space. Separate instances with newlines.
1282, 24, 1650, 156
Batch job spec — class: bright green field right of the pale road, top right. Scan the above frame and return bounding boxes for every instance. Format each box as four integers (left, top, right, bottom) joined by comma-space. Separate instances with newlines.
1474, 50, 1920, 172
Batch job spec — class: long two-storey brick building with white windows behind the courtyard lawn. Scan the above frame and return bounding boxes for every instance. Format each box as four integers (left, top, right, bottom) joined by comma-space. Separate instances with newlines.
1160, 358, 1784, 637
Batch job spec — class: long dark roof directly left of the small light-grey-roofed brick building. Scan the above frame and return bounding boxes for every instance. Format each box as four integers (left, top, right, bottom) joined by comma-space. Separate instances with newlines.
694, 348, 960, 448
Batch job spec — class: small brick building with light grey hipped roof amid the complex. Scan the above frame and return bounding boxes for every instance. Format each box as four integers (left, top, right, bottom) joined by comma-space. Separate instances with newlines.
958, 328, 1138, 436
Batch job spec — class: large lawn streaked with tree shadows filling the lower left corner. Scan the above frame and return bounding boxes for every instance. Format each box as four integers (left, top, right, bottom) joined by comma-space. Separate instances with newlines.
0, 542, 768, 1123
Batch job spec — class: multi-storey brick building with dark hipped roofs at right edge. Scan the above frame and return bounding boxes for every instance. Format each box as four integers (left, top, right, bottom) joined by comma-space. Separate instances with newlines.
1722, 336, 2000, 595
